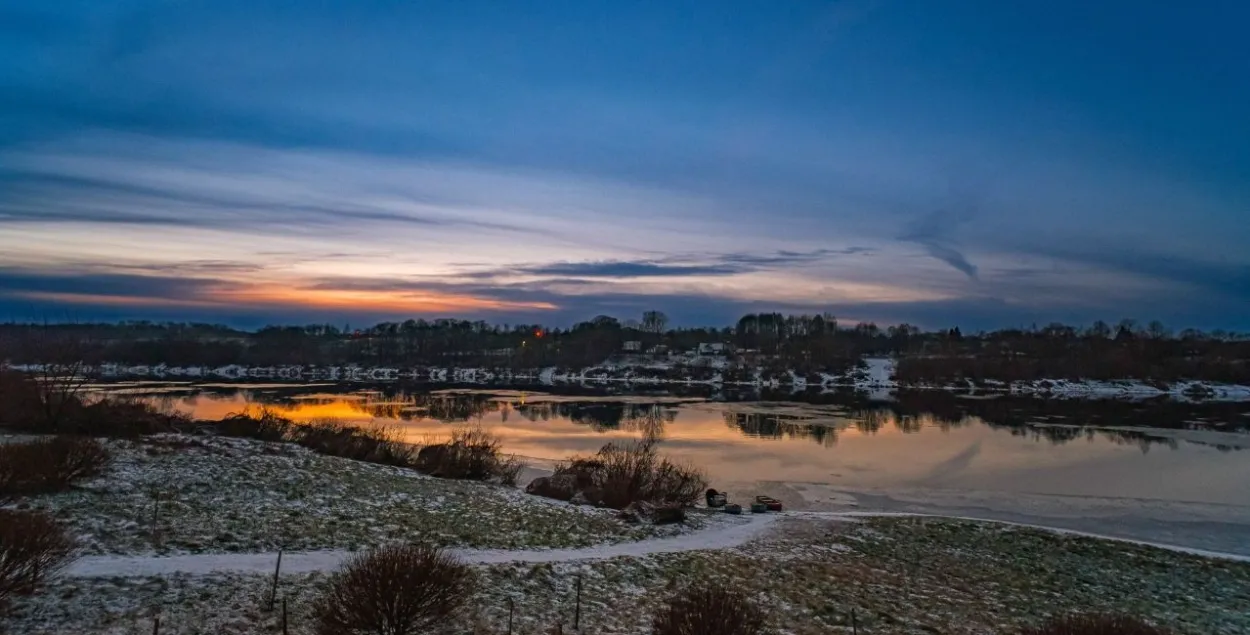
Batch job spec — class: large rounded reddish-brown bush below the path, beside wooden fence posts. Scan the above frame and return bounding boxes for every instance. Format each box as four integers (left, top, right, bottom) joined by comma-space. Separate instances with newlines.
318, 545, 474, 635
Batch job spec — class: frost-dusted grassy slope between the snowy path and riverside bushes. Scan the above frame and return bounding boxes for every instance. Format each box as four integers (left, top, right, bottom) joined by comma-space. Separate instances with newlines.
22, 435, 705, 555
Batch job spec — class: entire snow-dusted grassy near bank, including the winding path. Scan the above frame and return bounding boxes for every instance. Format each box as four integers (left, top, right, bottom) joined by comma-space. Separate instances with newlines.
4, 435, 1250, 635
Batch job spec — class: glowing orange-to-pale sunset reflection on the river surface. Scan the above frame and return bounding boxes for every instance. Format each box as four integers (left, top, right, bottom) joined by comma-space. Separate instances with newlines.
136, 391, 1250, 504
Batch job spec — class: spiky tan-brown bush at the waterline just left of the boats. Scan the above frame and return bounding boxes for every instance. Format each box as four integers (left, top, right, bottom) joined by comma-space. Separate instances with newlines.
553, 439, 708, 509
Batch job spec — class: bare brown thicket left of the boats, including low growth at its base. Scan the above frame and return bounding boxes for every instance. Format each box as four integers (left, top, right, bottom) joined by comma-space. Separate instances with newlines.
526, 436, 708, 515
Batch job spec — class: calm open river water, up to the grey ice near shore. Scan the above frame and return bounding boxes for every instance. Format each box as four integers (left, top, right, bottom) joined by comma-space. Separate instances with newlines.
98, 384, 1250, 505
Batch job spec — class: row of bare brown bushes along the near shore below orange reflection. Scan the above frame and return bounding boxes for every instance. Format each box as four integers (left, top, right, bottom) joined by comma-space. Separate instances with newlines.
216, 409, 524, 485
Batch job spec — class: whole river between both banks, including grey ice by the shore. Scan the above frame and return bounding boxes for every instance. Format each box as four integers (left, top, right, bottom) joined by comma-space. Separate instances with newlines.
90, 381, 1250, 558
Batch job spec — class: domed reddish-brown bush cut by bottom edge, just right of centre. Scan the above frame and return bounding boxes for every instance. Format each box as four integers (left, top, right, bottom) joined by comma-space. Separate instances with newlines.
651, 585, 768, 635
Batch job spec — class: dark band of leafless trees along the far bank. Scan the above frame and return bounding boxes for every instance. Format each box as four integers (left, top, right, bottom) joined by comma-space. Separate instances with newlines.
0, 311, 1250, 384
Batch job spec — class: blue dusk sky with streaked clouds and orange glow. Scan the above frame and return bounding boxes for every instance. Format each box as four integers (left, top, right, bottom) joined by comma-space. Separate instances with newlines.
0, 0, 1250, 329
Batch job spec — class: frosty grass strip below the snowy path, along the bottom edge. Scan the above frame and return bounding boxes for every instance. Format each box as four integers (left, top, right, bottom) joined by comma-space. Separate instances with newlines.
10, 516, 1250, 635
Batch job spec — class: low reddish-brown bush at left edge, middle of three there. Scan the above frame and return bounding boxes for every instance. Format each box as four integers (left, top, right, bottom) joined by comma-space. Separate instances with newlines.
0, 436, 113, 500
